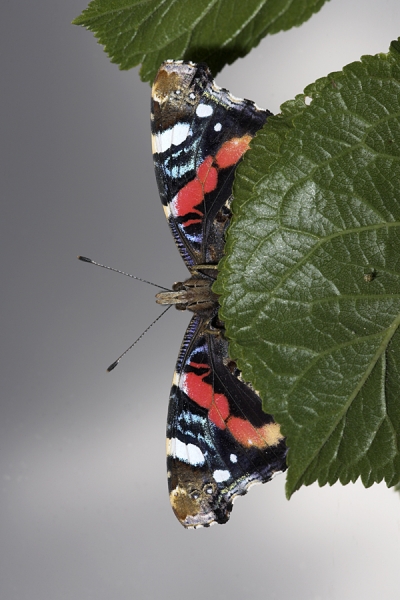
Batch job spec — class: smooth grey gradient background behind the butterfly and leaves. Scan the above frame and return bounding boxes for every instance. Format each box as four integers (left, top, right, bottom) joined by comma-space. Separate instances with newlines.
0, 0, 400, 600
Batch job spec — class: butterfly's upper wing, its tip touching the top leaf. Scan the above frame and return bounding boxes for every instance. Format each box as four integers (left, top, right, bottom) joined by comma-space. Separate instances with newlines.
151, 61, 269, 266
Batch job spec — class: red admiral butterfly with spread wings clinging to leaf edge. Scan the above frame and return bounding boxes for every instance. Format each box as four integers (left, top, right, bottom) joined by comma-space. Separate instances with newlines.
151, 61, 286, 527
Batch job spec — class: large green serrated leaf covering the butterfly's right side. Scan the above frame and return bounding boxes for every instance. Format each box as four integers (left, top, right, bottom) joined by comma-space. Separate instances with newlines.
215, 41, 400, 496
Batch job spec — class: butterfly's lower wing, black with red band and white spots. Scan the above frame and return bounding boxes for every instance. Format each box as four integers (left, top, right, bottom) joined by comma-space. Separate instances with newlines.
167, 316, 286, 527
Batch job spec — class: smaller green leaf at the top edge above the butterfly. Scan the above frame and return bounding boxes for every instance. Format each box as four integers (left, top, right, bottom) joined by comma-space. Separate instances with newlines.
73, 0, 326, 81
